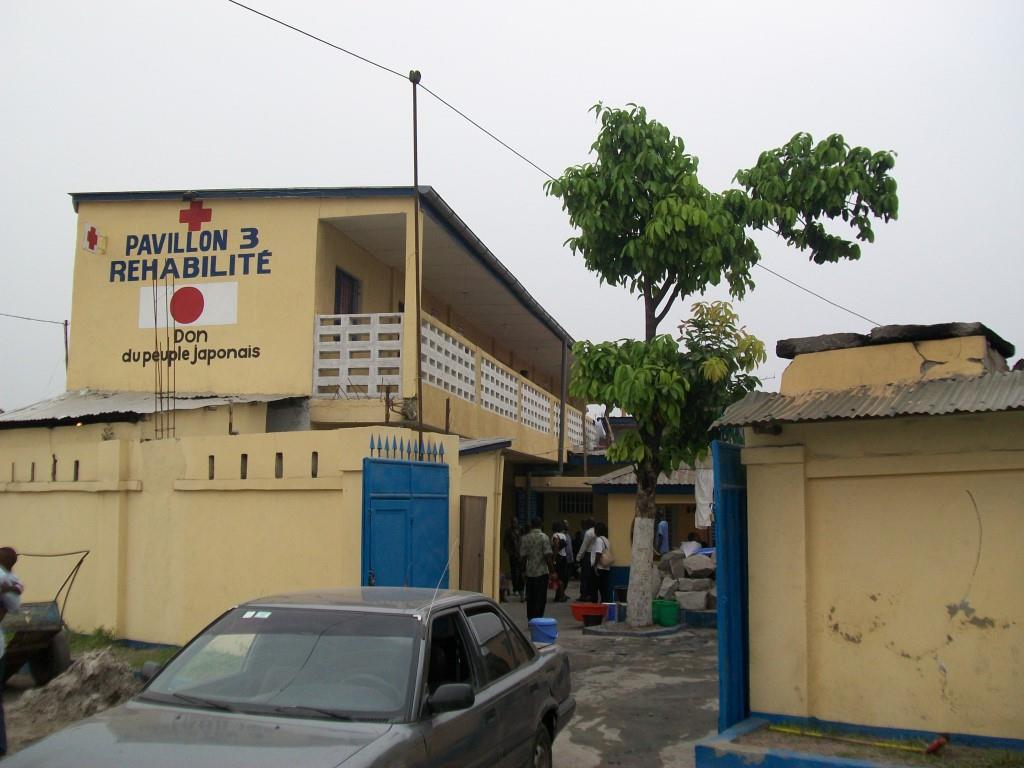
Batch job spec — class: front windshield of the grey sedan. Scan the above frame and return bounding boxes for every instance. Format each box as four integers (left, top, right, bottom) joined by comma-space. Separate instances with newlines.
142, 607, 419, 720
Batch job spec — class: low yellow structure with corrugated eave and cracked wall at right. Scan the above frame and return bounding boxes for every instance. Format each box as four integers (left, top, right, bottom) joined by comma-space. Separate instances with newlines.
716, 324, 1024, 745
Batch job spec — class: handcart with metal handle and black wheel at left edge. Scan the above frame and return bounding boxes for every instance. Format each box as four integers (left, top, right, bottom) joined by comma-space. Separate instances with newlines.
0, 551, 89, 685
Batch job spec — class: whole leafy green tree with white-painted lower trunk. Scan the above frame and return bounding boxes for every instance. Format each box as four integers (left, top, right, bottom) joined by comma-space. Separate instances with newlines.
545, 103, 899, 627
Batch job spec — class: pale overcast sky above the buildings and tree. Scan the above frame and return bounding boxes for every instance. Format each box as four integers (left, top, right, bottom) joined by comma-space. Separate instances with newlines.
0, 0, 1024, 410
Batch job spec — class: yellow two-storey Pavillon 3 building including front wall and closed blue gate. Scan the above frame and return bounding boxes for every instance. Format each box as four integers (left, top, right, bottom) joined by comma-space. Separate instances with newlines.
0, 187, 593, 642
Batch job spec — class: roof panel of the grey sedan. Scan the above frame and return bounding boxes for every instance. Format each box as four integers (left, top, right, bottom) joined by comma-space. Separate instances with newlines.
240, 587, 488, 614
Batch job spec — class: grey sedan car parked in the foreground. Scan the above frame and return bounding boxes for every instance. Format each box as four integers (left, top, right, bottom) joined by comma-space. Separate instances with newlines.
6, 588, 575, 768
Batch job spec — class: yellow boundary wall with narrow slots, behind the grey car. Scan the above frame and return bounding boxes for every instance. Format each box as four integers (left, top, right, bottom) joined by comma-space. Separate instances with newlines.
0, 425, 502, 643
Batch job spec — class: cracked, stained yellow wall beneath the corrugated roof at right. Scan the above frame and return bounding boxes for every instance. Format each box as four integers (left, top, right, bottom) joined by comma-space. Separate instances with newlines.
743, 412, 1024, 738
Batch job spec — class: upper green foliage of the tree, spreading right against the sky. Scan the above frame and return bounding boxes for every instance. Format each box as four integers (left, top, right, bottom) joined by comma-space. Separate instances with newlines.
546, 104, 899, 340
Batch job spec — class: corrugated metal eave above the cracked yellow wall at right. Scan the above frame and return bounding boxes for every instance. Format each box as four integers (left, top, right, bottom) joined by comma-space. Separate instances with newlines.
715, 371, 1024, 427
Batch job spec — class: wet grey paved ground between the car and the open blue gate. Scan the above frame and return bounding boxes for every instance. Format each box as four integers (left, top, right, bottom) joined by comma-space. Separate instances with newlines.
502, 584, 718, 768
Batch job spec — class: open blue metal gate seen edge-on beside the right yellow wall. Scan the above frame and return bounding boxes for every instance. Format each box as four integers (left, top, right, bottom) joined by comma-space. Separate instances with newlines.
711, 440, 751, 731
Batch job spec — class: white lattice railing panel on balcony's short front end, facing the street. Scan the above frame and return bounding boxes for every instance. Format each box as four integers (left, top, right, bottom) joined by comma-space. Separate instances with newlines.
313, 312, 401, 397
